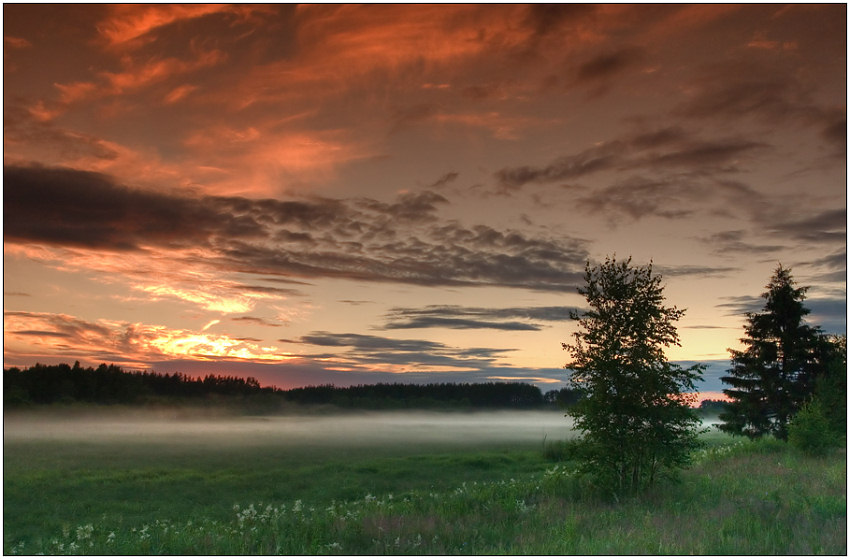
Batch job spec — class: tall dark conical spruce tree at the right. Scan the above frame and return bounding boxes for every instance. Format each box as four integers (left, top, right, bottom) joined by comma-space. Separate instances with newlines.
719, 264, 822, 440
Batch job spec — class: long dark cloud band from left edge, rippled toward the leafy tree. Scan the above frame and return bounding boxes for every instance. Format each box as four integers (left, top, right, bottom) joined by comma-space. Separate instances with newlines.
4, 166, 587, 295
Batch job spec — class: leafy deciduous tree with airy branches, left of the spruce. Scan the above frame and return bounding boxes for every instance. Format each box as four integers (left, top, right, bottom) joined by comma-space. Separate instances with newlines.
563, 259, 704, 493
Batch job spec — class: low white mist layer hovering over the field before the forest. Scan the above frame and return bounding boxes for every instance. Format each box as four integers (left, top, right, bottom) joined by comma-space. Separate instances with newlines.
4, 408, 573, 447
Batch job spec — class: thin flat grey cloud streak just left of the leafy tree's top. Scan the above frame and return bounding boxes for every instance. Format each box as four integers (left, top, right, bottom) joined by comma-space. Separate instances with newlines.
383, 305, 575, 331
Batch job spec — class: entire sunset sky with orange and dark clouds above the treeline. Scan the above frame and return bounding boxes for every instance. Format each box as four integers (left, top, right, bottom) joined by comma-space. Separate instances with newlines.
3, 4, 847, 396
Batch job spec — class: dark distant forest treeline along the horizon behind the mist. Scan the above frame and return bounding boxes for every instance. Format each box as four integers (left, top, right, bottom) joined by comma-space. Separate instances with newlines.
3, 362, 579, 411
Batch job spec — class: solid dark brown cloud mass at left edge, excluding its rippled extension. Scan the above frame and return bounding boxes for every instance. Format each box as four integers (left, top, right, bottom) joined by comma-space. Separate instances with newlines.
3, 166, 264, 251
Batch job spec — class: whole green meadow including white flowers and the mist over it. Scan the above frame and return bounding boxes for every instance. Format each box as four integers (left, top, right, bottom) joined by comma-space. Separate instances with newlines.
3, 406, 847, 555
